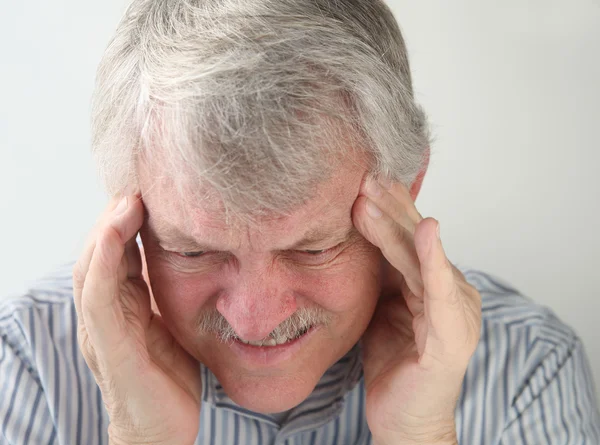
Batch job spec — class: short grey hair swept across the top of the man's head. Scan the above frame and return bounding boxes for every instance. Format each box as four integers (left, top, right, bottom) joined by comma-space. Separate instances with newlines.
92, 0, 429, 219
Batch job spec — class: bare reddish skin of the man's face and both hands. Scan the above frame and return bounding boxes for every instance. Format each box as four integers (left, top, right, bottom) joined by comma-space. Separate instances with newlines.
74, 150, 481, 444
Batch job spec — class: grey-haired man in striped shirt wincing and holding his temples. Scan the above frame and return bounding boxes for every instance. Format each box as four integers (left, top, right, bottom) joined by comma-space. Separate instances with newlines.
0, 0, 600, 445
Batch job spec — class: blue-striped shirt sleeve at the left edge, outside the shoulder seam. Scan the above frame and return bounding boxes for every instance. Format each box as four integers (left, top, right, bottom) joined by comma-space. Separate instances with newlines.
0, 317, 56, 445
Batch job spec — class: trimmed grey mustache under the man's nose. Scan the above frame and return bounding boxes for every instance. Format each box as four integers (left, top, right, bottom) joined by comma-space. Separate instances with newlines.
196, 307, 331, 343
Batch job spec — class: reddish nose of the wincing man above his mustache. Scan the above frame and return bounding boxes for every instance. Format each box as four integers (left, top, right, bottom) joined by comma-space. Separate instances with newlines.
216, 270, 296, 341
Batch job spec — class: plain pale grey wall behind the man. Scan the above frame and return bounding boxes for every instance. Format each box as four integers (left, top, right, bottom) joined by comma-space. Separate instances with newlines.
0, 0, 600, 398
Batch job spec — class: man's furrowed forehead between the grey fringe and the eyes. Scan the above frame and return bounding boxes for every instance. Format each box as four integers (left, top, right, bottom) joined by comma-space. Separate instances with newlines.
140, 163, 366, 250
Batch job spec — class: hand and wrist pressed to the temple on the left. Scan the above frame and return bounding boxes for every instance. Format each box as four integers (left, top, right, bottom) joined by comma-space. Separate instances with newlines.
73, 196, 201, 445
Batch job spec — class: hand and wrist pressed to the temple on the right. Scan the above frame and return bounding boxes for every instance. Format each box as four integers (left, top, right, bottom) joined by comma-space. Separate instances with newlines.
352, 179, 481, 445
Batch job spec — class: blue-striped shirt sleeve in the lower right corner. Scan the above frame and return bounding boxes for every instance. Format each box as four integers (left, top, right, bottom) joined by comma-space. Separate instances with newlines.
500, 338, 600, 445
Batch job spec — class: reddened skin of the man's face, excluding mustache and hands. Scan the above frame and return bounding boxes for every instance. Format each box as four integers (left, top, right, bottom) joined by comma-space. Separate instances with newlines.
141, 158, 382, 413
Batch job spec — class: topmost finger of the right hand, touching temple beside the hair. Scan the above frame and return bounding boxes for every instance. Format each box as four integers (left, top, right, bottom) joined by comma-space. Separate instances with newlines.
361, 178, 423, 234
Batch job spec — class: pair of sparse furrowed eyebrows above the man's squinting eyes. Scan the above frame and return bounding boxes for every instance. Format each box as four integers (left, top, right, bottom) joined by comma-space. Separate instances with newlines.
146, 213, 358, 251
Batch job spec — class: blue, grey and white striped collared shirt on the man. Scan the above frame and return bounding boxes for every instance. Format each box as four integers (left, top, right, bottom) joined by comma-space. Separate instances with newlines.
0, 265, 600, 445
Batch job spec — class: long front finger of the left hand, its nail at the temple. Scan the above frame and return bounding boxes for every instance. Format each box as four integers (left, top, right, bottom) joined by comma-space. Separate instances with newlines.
81, 197, 143, 353
